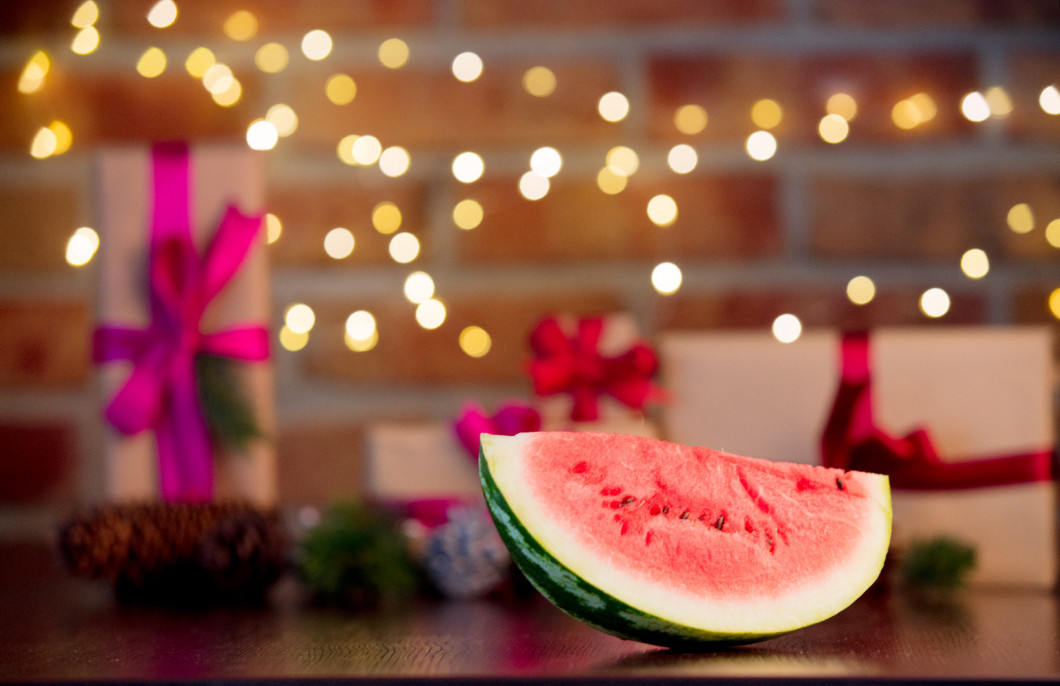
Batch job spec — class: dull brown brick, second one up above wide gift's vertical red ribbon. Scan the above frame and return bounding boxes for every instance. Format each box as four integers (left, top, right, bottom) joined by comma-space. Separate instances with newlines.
809, 175, 1007, 260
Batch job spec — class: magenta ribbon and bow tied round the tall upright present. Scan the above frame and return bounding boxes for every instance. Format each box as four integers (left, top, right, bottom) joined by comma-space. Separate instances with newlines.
92, 143, 269, 502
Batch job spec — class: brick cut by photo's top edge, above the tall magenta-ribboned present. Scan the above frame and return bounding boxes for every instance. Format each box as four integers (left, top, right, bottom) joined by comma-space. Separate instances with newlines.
108, 0, 436, 38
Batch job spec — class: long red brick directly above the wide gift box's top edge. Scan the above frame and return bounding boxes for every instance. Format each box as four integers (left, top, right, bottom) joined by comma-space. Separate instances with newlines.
652, 284, 987, 331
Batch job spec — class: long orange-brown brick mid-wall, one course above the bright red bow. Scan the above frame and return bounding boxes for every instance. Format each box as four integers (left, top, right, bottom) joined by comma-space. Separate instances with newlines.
458, 172, 781, 263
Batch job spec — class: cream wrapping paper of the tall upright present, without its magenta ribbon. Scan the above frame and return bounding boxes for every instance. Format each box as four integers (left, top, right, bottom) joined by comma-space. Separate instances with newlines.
95, 145, 276, 505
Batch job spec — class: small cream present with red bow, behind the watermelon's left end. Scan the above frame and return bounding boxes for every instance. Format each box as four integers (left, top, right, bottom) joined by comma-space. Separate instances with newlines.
528, 315, 660, 436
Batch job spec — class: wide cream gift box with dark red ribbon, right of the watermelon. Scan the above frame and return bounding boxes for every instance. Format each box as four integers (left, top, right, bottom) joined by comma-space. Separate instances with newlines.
659, 327, 1058, 588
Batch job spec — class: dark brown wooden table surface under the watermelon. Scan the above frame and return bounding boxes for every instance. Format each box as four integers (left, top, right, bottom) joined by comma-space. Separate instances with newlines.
0, 547, 1060, 684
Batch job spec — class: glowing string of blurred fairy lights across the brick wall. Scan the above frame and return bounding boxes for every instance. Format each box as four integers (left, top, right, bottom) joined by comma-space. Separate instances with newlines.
18, 0, 1060, 357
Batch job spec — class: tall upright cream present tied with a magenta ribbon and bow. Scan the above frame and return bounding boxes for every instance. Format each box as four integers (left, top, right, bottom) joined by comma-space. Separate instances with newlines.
93, 143, 276, 505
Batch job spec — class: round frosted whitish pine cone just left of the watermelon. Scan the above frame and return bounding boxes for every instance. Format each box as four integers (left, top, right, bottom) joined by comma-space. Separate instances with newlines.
423, 508, 511, 599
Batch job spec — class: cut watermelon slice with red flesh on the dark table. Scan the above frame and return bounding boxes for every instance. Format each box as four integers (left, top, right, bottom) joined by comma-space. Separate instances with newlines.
479, 432, 890, 649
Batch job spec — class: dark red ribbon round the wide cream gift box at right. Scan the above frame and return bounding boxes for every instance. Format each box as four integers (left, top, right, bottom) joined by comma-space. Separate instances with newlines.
820, 332, 1053, 490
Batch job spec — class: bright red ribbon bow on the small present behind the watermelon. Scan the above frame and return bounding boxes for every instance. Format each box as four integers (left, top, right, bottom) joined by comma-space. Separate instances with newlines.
530, 317, 658, 422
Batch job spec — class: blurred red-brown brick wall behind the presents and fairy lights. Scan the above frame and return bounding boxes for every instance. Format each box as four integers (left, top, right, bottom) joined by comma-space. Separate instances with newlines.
0, 0, 1060, 532
